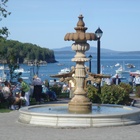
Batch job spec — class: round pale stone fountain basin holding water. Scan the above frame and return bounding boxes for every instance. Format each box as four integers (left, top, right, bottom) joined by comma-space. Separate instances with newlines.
18, 104, 140, 128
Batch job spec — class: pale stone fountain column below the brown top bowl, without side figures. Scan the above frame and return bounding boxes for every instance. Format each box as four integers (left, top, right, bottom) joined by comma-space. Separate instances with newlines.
68, 42, 92, 113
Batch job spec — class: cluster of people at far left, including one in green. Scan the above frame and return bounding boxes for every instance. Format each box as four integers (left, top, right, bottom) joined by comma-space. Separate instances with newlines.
0, 78, 30, 110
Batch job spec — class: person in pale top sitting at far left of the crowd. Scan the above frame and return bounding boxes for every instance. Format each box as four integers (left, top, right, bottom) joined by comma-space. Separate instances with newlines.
2, 81, 21, 110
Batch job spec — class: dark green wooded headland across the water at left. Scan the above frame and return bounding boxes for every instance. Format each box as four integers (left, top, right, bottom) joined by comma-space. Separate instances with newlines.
0, 39, 55, 63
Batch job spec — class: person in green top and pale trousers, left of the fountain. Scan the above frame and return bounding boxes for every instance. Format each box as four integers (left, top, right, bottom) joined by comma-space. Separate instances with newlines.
18, 78, 30, 106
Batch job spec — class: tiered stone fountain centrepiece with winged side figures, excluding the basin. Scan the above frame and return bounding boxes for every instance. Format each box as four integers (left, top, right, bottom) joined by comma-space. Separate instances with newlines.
51, 15, 109, 113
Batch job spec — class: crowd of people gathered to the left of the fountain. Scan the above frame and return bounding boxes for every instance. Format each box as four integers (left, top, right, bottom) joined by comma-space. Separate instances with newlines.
0, 75, 60, 110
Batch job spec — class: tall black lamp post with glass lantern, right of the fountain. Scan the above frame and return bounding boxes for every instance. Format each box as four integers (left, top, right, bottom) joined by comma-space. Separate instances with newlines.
95, 28, 103, 93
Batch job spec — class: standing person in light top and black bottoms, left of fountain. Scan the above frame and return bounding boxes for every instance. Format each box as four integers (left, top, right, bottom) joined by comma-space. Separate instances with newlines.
32, 75, 43, 104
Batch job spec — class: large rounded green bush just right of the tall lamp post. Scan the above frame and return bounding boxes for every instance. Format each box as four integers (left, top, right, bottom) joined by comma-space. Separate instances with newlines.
100, 85, 129, 105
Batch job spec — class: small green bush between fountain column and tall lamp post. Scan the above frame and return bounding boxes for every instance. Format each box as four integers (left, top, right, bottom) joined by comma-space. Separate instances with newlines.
87, 85, 101, 103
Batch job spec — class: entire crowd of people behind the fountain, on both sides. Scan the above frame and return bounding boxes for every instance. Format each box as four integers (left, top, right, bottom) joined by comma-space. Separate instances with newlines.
0, 71, 140, 110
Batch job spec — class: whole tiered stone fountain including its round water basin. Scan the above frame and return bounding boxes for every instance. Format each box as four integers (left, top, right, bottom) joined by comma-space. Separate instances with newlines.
19, 15, 140, 127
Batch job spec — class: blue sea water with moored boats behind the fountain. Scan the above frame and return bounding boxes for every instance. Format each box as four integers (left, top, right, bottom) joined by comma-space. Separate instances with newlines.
0, 51, 140, 83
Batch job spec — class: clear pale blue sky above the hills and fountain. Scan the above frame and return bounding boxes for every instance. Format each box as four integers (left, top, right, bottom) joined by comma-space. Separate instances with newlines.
0, 0, 140, 51
